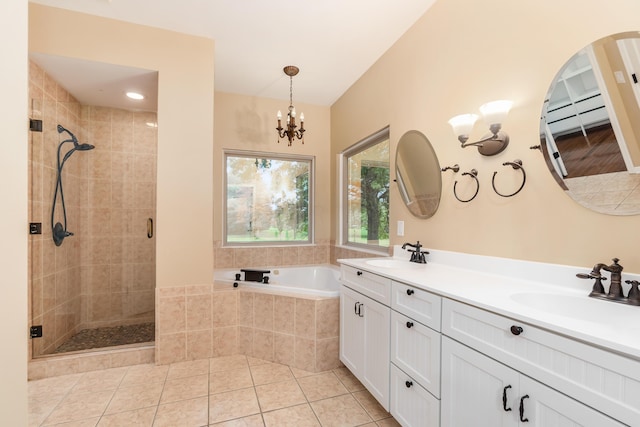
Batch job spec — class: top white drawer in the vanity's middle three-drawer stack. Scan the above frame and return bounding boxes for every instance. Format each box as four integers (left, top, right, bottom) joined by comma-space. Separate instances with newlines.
391, 282, 442, 331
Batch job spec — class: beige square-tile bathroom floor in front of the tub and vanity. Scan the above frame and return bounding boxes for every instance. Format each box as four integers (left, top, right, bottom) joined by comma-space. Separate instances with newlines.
29, 356, 399, 427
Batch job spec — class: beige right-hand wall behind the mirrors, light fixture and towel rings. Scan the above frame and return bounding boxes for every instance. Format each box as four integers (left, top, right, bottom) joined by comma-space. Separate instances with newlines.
331, 0, 640, 272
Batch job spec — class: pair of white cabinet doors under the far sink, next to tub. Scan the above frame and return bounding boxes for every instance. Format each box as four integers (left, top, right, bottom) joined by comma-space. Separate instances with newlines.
340, 286, 391, 411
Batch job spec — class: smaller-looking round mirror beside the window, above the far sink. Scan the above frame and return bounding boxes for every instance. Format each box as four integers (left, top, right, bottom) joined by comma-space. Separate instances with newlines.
396, 130, 442, 218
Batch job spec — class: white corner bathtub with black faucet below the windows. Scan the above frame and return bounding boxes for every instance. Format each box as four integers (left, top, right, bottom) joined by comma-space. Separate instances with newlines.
213, 264, 340, 298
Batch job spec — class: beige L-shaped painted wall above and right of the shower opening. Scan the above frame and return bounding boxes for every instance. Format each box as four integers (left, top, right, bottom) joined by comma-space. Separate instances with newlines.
29, 4, 214, 287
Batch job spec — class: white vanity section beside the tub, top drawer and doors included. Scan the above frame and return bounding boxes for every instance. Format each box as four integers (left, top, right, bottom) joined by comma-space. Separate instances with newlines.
340, 266, 391, 411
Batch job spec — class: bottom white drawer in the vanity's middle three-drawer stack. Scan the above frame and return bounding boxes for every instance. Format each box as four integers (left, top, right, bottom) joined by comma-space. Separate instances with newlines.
391, 363, 440, 427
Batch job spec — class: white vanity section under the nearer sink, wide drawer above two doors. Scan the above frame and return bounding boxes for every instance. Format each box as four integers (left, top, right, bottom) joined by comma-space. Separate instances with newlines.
441, 299, 640, 427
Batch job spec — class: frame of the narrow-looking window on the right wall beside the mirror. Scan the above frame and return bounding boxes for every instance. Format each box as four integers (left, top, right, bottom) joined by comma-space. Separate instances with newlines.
338, 126, 392, 254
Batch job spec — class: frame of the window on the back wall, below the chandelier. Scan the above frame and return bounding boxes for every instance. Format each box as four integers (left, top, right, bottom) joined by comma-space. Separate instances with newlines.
222, 149, 316, 247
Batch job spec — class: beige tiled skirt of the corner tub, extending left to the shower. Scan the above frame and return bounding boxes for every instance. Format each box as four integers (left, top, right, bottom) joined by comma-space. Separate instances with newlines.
156, 284, 341, 372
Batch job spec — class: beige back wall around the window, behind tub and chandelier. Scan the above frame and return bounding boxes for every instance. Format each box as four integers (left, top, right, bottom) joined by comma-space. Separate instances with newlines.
213, 91, 332, 268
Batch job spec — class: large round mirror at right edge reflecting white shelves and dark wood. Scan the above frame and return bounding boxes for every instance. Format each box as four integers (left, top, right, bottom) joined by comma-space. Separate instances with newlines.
540, 32, 640, 215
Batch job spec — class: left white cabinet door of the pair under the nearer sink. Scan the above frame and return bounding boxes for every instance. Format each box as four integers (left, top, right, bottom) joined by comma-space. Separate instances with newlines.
440, 336, 519, 427
